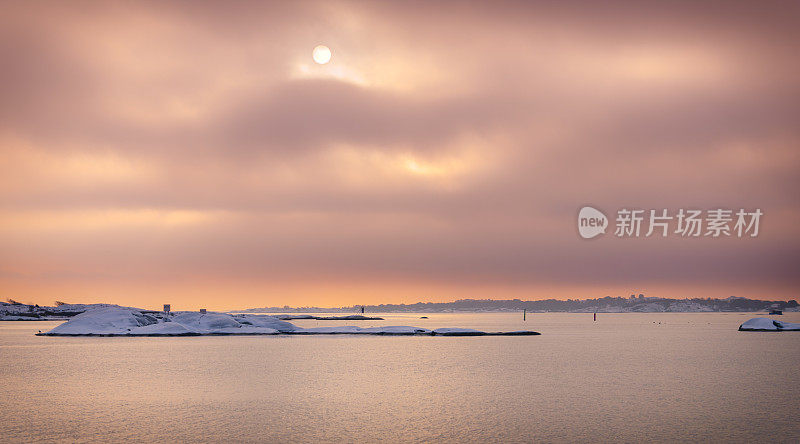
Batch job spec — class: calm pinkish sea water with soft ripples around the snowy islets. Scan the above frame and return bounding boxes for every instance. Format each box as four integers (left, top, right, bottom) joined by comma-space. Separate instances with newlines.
0, 313, 800, 442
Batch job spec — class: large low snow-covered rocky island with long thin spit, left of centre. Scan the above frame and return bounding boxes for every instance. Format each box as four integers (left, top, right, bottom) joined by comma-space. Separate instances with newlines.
38, 306, 540, 336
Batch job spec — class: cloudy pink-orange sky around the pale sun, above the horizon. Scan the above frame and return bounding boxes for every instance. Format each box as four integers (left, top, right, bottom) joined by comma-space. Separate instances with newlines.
0, 2, 800, 309
